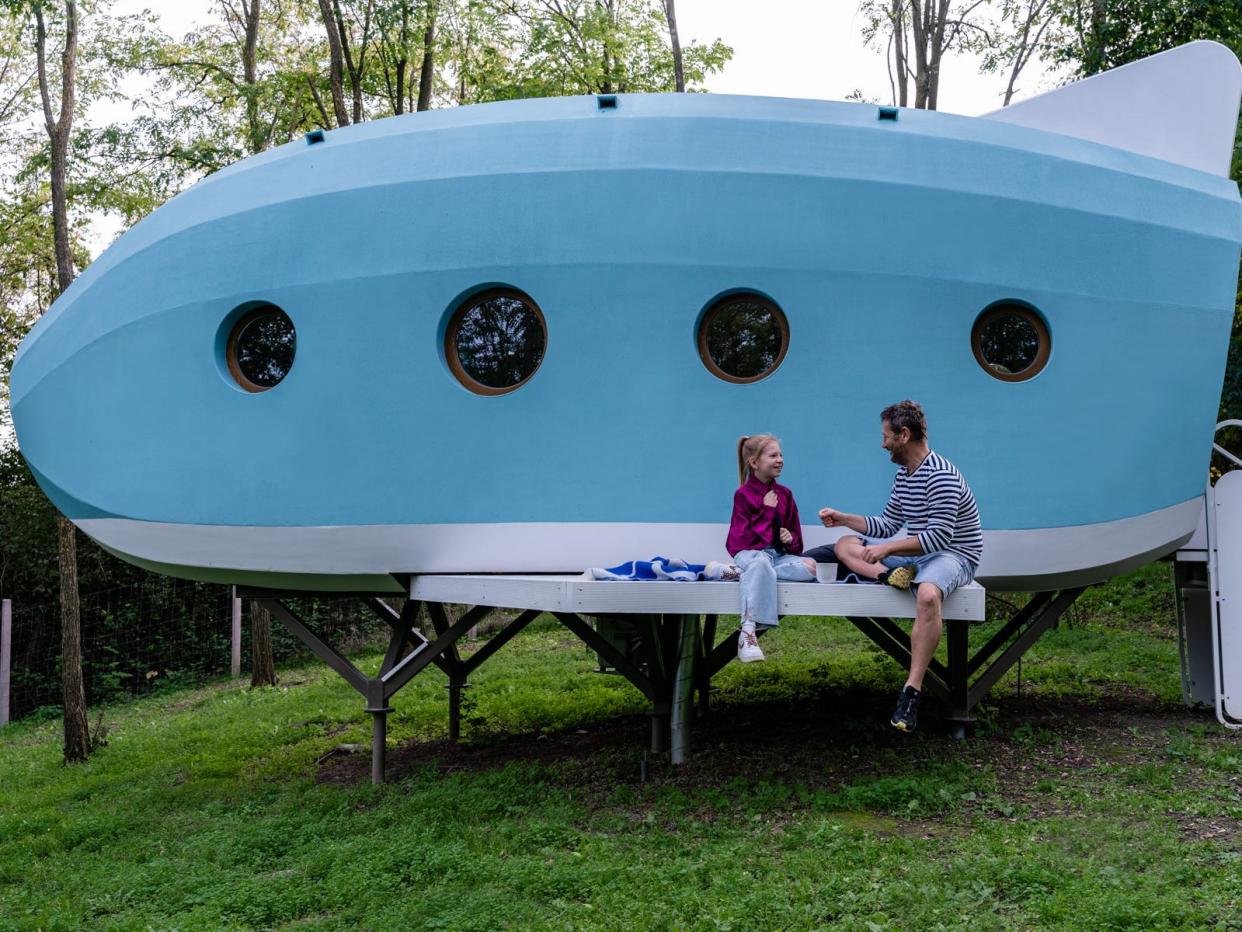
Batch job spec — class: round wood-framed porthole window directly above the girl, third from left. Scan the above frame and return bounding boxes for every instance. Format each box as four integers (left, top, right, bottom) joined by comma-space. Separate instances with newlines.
698, 295, 789, 381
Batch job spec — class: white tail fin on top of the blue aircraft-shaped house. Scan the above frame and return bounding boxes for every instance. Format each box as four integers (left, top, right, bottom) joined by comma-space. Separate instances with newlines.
982, 41, 1242, 175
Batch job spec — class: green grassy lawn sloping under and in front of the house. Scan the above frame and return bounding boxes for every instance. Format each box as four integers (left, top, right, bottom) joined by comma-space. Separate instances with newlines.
0, 565, 1242, 930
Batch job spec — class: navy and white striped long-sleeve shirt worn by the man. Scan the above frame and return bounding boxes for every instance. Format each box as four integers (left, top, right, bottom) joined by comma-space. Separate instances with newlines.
867, 452, 984, 565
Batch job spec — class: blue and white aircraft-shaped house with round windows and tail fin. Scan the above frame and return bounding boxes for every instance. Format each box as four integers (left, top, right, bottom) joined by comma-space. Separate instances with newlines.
11, 42, 1242, 592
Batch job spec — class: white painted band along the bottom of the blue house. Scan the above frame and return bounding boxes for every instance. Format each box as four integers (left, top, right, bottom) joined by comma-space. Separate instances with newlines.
76, 497, 1202, 589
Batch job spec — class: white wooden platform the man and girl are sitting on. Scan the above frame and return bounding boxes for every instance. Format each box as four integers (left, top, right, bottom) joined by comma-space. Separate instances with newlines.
410, 574, 986, 621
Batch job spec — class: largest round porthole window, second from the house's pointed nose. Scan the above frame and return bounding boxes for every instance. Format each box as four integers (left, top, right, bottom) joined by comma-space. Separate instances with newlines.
445, 290, 548, 395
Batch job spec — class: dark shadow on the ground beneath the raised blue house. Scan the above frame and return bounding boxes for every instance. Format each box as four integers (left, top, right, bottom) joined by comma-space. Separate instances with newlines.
317, 690, 1207, 798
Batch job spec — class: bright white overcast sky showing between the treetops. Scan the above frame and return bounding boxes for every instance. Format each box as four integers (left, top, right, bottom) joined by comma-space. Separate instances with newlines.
116, 0, 1054, 116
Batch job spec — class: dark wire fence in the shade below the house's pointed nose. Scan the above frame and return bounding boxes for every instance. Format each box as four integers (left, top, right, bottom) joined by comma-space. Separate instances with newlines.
10, 575, 388, 720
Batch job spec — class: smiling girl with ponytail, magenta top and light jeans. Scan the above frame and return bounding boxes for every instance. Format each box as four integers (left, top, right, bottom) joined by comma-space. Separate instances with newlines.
724, 434, 815, 664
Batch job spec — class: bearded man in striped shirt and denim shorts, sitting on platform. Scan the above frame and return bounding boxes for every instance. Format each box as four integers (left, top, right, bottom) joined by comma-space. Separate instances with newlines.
820, 400, 984, 732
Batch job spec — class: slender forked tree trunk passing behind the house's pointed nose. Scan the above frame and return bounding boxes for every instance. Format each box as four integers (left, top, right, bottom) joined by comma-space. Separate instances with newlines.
35, 0, 91, 763
